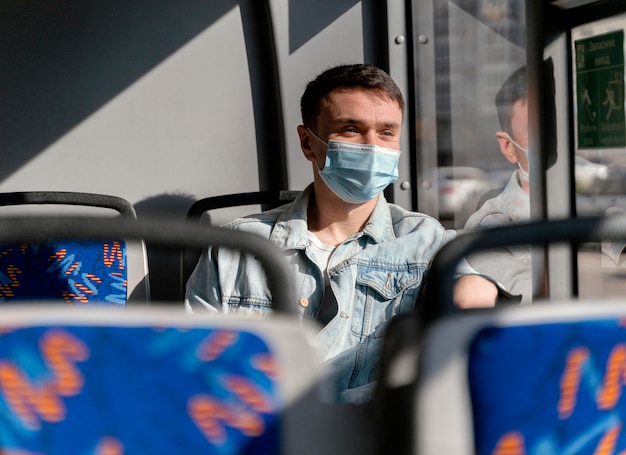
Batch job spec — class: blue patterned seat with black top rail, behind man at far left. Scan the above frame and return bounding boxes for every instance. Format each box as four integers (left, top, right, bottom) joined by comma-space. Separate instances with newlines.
0, 191, 150, 306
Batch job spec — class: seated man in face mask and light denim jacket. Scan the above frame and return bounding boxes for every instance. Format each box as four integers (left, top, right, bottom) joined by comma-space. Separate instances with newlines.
186, 64, 498, 403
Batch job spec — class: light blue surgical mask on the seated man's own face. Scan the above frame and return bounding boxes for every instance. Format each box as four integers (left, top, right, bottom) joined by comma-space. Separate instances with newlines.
309, 130, 402, 204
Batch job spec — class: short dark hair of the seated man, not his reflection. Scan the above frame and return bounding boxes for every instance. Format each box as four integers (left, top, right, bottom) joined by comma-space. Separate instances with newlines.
300, 63, 404, 128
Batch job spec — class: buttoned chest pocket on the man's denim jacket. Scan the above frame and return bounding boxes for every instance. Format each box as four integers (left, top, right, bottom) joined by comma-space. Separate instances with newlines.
352, 267, 424, 338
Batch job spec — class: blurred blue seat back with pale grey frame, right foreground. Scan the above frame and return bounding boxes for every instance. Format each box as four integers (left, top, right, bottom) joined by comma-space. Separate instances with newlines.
412, 300, 626, 455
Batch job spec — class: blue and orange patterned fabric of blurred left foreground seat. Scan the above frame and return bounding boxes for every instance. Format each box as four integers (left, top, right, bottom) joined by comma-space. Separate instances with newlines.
0, 325, 281, 455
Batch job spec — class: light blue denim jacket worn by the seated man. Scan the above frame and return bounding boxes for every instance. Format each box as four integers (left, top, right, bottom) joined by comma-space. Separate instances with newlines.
186, 186, 476, 402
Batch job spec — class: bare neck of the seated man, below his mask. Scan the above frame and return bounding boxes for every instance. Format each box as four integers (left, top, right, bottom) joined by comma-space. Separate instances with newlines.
307, 185, 378, 245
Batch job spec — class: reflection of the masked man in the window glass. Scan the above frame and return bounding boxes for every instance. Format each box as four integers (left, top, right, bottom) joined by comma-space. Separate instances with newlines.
465, 67, 532, 303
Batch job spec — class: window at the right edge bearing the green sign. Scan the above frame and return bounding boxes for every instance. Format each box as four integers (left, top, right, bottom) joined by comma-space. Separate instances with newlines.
571, 14, 626, 297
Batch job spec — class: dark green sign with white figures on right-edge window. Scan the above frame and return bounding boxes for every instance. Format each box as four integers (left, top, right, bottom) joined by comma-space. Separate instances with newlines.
574, 30, 626, 148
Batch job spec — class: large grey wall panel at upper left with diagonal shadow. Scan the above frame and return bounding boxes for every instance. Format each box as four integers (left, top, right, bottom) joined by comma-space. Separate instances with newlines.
0, 0, 258, 212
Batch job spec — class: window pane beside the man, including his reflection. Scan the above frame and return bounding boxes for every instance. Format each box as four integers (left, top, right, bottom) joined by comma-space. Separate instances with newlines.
414, 0, 540, 303
